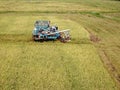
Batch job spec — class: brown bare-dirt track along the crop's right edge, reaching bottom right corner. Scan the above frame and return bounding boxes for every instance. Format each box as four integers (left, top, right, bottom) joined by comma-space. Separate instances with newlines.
86, 29, 120, 89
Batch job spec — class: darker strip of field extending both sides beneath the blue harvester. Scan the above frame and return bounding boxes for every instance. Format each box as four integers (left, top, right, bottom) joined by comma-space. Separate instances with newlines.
0, 34, 91, 44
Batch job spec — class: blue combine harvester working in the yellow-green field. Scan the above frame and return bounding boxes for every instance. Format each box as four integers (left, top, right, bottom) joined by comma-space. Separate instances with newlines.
32, 20, 70, 43
